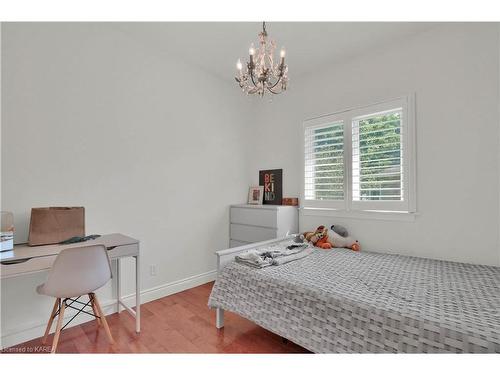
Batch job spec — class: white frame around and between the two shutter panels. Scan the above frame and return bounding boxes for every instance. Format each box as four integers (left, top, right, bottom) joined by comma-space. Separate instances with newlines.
301, 93, 416, 213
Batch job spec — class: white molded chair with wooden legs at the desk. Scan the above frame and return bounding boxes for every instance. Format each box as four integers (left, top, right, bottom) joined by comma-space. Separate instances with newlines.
36, 245, 114, 353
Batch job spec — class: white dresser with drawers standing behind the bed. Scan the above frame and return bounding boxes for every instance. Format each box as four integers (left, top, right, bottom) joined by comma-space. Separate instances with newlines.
229, 204, 299, 247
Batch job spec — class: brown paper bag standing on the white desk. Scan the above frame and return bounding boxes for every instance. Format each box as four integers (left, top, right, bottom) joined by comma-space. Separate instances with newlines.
28, 207, 85, 246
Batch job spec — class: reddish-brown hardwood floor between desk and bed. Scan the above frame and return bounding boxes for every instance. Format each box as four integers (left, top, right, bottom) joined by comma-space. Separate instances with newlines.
5, 283, 307, 353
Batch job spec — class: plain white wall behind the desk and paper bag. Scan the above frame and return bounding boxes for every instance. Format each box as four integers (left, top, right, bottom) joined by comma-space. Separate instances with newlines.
1, 23, 254, 346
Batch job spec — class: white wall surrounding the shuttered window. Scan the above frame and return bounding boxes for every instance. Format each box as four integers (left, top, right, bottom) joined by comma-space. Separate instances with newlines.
249, 24, 500, 265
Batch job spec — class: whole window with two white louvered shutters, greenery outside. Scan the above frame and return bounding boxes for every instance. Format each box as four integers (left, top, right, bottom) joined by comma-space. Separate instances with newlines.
302, 97, 415, 212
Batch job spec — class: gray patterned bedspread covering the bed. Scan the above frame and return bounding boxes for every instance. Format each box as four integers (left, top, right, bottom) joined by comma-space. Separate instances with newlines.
208, 245, 500, 353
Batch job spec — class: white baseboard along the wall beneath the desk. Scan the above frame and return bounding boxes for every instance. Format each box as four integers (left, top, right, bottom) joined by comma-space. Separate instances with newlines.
0, 270, 217, 349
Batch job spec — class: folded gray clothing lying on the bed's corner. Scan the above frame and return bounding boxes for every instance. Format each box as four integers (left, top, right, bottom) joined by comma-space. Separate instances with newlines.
235, 243, 314, 268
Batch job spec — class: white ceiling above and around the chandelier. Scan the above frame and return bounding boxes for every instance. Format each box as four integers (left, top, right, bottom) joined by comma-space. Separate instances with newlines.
113, 22, 437, 80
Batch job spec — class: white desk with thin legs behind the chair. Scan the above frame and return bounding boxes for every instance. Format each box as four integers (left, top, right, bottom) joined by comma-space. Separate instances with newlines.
0, 233, 141, 333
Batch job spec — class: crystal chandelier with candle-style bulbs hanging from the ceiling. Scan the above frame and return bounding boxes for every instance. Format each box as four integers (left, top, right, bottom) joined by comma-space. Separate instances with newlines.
234, 22, 288, 97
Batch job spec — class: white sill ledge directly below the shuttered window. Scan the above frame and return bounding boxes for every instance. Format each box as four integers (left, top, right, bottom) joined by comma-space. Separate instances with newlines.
300, 207, 418, 222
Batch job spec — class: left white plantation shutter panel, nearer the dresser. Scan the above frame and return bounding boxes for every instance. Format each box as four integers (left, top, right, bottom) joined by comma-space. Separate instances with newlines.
304, 121, 345, 207
